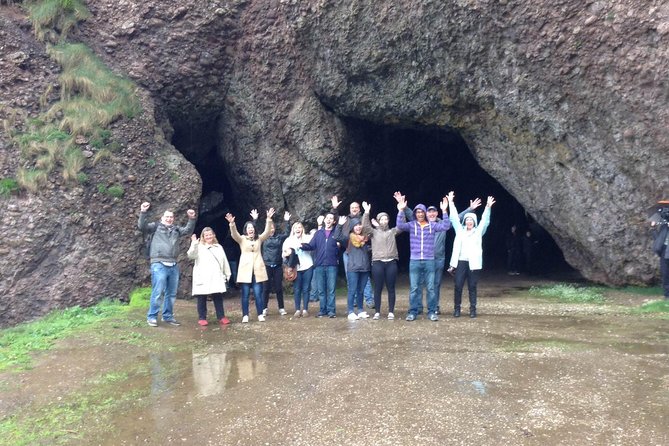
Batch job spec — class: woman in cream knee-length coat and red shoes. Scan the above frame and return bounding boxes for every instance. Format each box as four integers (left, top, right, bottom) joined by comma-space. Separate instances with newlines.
188, 227, 232, 326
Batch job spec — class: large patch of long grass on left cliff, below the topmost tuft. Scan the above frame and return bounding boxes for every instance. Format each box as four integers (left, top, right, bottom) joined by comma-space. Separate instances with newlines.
14, 44, 141, 192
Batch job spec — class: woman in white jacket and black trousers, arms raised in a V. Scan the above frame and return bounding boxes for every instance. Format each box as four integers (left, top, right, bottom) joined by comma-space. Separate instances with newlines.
448, 191, 495, 317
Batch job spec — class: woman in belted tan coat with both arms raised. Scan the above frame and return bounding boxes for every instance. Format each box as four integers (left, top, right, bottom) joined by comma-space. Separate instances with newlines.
225, 208, 274, 323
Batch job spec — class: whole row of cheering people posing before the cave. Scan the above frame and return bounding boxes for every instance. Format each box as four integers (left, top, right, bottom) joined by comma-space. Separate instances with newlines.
138, 192, 495, 326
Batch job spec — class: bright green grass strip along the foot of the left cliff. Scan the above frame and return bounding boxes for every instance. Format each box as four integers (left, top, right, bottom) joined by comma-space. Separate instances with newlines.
0, 301, 128, 371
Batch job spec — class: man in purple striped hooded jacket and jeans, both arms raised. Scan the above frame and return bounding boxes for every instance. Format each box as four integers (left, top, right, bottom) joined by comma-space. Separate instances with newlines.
394, 192, 451, 321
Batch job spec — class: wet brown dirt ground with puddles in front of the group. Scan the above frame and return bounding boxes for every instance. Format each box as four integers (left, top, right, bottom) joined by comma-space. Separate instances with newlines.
0, 277, 669, 445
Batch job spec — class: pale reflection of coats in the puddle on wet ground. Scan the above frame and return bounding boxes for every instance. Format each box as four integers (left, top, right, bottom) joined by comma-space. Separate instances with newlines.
193, 352, 267, 396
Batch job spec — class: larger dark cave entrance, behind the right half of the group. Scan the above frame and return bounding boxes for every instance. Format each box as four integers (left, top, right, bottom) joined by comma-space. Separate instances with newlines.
343, 119, 572, 274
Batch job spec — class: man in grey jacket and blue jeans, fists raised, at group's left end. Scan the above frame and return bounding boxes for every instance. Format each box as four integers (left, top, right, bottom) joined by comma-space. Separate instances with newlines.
137, 202, 195, 327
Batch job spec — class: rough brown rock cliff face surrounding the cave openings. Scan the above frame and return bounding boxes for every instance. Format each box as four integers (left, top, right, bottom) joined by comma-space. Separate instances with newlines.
0, 0, 669, 323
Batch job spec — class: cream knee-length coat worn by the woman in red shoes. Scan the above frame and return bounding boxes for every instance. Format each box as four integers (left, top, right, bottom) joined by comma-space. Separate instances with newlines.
188, 241, 232, 296
